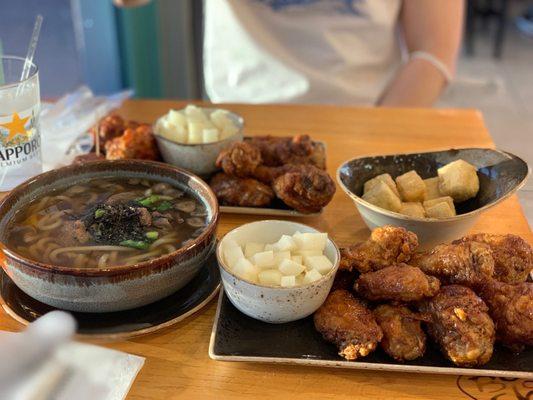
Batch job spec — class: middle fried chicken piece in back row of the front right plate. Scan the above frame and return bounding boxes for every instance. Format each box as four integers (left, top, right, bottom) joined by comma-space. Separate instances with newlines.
411, 242, 494, 288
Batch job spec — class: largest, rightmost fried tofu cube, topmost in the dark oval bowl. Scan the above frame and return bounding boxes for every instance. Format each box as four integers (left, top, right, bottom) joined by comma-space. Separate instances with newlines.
438, 160, 479, 202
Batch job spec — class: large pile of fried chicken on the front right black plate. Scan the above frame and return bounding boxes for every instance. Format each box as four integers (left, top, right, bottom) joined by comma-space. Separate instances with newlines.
314, 226, 533, 367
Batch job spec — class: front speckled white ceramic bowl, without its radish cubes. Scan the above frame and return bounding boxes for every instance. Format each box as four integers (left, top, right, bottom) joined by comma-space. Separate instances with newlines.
217, 220, 340, 324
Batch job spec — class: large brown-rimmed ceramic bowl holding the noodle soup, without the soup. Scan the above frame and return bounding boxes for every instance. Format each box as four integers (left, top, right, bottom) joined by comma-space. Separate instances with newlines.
0, 160, 219, 312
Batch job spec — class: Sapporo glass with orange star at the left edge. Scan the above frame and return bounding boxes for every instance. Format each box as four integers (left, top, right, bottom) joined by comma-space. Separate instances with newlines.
0, 56, 42, 192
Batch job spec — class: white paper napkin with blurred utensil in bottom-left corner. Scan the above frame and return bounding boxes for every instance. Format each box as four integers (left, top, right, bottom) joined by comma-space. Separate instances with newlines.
0, 311, 144, 400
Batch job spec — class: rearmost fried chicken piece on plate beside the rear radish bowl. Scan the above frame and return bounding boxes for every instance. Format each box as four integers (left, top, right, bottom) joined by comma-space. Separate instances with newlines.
246, 135, 326, 169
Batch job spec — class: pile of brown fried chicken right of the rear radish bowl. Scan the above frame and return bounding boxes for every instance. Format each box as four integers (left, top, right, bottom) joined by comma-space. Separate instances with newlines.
210, 135, 335, 213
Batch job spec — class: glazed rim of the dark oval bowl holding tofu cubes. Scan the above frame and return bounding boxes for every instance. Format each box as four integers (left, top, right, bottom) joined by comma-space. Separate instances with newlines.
336, 147, 531, 223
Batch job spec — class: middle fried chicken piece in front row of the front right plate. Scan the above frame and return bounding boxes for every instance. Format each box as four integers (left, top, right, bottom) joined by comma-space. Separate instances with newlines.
374, 304, 426, 361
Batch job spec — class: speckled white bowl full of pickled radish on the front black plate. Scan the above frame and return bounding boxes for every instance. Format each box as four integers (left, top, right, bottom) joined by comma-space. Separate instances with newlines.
217, 220, 340, 323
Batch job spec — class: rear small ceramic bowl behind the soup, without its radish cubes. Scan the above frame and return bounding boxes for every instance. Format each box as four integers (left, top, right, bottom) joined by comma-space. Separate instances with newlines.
154, 107, 244, 177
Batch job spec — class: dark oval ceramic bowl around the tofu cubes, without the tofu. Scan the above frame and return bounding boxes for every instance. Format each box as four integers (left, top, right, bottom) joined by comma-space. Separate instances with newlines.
337, 148, 529, 248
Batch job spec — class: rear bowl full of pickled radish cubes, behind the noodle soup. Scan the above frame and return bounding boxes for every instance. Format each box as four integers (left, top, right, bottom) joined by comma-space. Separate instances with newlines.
154, 104, 244, 176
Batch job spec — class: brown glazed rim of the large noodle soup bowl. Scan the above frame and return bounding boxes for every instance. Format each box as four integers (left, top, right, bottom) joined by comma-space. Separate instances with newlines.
0, 160, 220, 277
